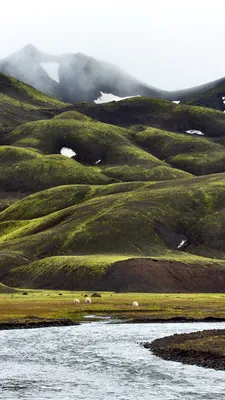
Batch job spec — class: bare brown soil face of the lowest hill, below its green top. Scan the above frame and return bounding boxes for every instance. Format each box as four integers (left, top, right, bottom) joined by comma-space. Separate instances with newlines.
1, 258, 225, 293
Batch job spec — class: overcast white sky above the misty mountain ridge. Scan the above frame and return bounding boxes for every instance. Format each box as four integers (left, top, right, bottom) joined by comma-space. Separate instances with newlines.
0, 0, 225, 90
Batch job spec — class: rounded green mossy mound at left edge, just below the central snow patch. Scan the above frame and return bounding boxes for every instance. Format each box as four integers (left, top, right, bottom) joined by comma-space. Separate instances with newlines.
0, 146, 110, 193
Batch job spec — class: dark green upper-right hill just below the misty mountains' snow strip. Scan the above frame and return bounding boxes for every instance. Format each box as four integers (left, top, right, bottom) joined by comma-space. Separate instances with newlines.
74, 97, 225, 137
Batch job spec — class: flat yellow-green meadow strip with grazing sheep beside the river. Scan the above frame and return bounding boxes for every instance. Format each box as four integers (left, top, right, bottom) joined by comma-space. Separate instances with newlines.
0, 289, 225, 322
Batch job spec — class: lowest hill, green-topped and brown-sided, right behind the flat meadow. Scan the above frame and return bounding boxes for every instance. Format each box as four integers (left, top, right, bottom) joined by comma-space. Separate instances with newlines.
2, 252, 225, 293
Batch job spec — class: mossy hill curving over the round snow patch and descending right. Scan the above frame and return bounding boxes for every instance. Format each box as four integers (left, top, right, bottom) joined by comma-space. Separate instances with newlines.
5, 117, 190, 183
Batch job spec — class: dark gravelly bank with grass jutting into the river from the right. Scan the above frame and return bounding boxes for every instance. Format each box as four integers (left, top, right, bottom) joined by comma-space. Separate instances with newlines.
143, 329, 225, 371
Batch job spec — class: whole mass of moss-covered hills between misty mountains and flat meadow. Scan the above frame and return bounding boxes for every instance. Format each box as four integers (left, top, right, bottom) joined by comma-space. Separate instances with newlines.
0, 72, 225, 292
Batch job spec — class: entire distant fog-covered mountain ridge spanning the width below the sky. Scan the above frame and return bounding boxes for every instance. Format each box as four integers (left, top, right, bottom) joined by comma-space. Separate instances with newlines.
0, 44, 225, 111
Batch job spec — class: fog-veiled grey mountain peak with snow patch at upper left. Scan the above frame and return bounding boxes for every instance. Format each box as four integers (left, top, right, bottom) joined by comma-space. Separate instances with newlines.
0, 44, 165, 103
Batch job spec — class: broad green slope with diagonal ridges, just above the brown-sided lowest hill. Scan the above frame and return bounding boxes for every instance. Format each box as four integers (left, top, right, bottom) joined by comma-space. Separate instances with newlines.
0, 174, 225, 256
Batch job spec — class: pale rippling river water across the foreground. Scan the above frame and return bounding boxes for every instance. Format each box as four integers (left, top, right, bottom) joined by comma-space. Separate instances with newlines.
0, 322, 225, 400
